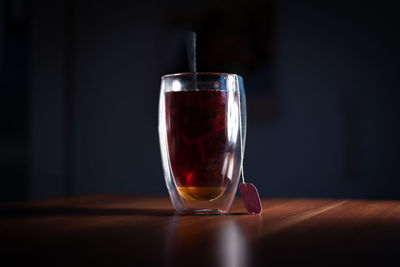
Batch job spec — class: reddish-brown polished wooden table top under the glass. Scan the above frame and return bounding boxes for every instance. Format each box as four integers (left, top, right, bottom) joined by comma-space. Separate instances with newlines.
0, 195, 400, 267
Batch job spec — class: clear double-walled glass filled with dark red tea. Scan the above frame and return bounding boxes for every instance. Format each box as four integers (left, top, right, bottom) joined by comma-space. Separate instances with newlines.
158, 72, 246, 214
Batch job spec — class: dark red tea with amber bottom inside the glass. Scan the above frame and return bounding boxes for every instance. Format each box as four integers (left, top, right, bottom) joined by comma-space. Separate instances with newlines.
165, 90, 238, 201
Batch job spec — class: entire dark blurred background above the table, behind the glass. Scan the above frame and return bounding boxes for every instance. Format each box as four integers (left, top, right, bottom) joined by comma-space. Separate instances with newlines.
0, 0, 400, 201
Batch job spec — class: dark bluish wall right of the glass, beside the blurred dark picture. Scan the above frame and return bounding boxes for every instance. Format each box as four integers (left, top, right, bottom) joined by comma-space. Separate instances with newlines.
246, 1, 400, 198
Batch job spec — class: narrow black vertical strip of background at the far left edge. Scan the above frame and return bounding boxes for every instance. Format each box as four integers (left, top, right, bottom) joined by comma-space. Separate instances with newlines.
0, 0, 29, 201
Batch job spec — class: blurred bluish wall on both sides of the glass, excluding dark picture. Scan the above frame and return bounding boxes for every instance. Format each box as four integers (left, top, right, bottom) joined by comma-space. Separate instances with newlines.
1, 0, 400, 199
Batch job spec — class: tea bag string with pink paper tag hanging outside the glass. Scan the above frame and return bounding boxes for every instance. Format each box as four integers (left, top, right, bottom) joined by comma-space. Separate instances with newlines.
236, 77, 262, 214
